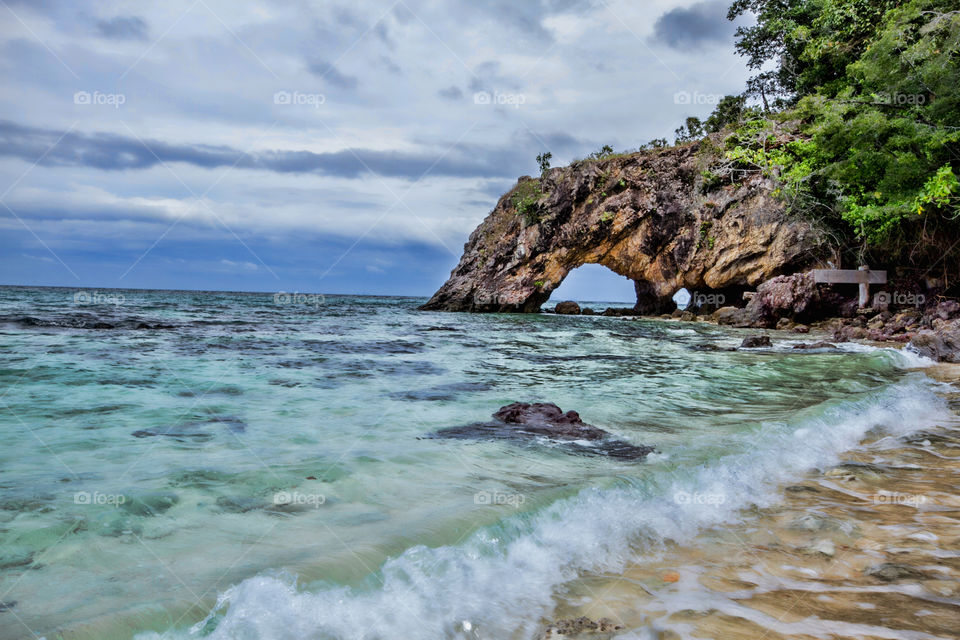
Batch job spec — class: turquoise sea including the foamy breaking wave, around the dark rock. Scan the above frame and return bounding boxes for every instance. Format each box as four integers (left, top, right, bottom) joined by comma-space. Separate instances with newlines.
0, 288, 950, 639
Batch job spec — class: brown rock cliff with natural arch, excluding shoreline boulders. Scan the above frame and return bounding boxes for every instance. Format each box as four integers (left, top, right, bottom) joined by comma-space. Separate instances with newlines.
422, 143, 819, 313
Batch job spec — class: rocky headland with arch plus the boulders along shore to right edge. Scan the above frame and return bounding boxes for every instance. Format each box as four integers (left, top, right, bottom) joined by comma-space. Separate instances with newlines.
422, 143, 960, 362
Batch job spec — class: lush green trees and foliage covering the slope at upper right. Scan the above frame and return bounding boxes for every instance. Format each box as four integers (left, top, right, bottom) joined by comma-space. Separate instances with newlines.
700, 0, 960, 267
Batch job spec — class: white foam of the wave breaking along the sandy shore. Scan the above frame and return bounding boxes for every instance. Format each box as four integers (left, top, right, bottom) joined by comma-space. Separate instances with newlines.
138, 376, 949, 640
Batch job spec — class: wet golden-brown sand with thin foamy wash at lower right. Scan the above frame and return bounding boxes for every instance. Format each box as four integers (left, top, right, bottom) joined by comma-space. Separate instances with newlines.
544, 365, 960, 640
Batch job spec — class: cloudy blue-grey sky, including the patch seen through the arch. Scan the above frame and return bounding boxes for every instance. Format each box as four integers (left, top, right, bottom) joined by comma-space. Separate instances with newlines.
0, 0, 749, 300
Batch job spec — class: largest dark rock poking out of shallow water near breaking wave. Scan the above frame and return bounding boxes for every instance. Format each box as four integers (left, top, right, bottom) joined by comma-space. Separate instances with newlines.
435, 402, 655, 459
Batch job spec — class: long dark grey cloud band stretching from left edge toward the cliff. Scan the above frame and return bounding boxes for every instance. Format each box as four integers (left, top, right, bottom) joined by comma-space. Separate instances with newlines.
0, 121, 525, 179
